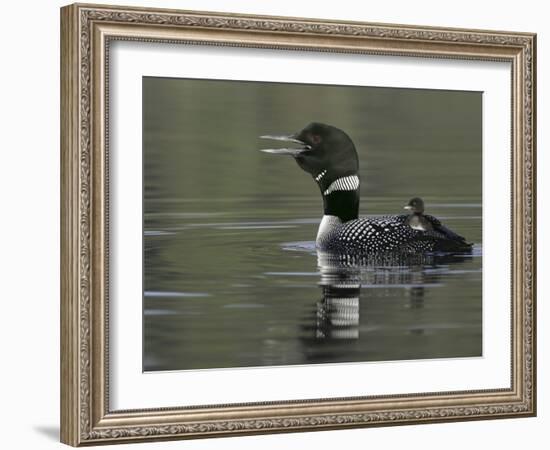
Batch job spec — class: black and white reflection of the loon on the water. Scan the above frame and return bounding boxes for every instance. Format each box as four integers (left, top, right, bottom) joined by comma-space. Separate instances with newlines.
305, 251, 471, 346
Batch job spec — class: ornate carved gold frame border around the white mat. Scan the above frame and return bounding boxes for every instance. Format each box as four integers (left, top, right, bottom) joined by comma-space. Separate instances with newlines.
61, 4, 536, 446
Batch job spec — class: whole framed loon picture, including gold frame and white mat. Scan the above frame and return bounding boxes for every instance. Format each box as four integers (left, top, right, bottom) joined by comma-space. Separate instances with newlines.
61, 4, 536, 446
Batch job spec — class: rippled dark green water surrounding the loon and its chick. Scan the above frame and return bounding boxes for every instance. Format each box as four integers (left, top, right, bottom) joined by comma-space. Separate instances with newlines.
143, 78, 482, 371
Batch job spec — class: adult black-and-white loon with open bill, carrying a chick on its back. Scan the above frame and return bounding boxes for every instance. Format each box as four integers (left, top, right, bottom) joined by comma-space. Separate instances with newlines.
260, 122, 472, 254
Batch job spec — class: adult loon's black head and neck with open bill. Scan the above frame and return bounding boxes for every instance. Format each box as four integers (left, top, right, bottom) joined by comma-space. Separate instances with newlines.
260, 122, 359, 222
